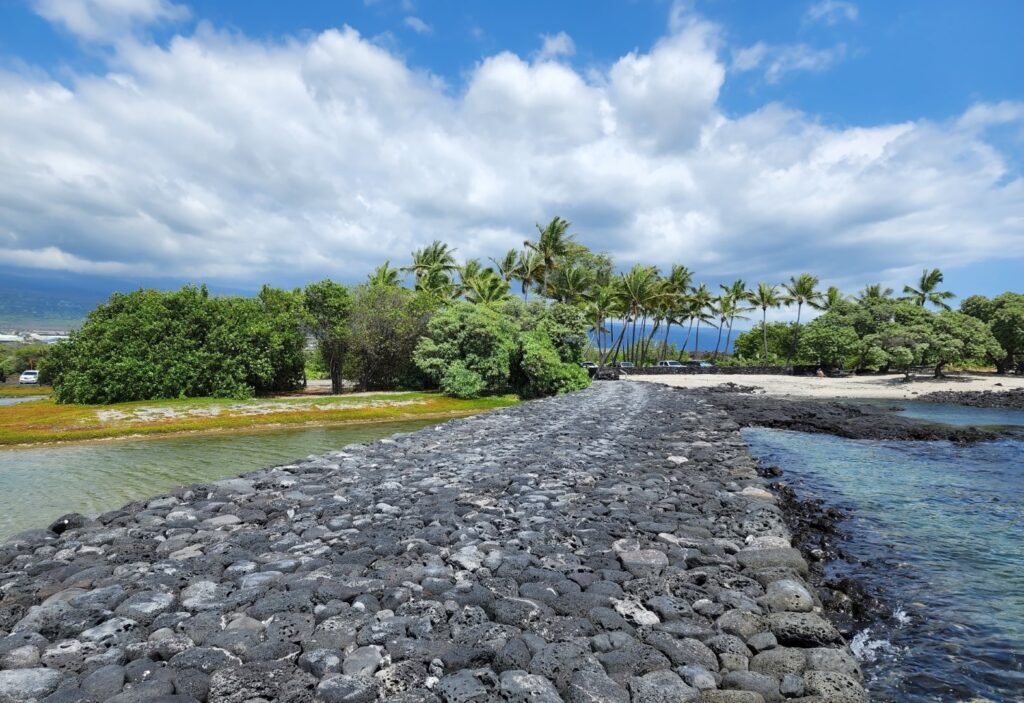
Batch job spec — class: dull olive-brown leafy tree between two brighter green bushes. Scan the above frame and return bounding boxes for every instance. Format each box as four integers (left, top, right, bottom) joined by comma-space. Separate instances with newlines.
345, 285, 435, 391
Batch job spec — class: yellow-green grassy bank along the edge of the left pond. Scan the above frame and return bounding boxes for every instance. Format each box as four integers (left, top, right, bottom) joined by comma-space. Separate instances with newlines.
0, 393, 518, 449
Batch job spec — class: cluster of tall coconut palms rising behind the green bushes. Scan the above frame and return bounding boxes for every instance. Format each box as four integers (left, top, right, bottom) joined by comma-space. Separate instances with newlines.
369, 217, 953, 365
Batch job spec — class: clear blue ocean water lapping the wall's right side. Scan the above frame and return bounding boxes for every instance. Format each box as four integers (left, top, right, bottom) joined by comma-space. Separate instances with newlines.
743, 403, 1024, 703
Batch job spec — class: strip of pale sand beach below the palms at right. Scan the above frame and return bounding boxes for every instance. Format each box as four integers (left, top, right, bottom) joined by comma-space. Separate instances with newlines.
624, 374, 1024, 399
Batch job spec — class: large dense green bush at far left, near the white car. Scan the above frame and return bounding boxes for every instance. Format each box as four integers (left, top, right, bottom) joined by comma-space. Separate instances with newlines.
41, 287, 305, 403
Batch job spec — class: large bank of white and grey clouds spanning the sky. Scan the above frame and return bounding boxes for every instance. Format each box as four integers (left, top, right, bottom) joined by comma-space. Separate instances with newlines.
0, 6, 1024, 288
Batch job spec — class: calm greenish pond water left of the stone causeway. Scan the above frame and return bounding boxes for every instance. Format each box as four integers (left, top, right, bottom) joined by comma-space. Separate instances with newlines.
0, 421, 436, 540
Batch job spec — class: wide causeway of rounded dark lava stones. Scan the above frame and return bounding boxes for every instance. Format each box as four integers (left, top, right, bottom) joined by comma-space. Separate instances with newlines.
0, 383, 868, 703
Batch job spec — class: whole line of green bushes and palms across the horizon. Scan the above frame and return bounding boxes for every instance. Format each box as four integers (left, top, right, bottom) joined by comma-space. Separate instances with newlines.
44, 217, 1024, 403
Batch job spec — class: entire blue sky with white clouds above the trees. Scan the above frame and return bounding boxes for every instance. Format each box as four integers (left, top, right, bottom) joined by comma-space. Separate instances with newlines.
0, 0, 1024, 304
